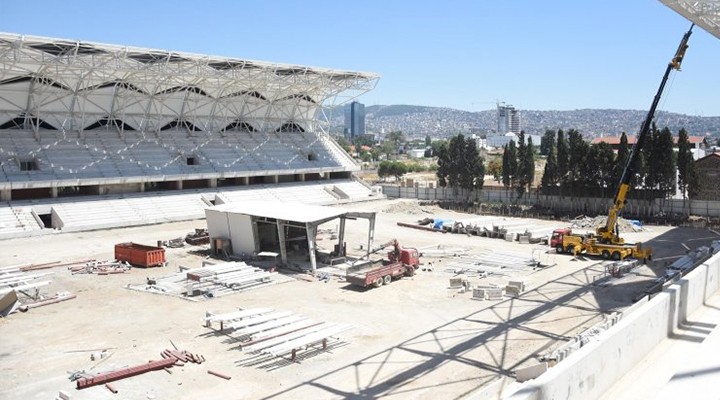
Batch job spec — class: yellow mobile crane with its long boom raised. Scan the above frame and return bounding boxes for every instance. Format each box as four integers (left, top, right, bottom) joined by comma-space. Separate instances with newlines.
550, 24, 695, 261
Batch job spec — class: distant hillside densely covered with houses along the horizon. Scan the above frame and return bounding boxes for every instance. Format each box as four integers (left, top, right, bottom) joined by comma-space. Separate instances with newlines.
328, 105, 720, 138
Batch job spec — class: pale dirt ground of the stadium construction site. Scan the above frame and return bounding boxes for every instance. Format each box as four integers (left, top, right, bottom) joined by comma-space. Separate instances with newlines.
0, 200, 718, 399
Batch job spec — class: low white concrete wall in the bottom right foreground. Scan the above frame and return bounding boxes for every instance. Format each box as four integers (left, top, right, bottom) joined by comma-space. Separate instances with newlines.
503, 253, 720, 400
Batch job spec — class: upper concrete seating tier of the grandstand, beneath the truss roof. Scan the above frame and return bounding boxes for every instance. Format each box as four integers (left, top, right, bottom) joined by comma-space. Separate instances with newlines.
0, 130, 354, 182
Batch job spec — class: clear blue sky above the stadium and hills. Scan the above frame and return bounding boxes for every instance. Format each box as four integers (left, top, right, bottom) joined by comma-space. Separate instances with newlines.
0, 0, 720, 116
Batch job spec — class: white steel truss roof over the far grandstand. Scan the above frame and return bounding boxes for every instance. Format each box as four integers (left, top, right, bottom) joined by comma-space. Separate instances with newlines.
0, 33, 379, 132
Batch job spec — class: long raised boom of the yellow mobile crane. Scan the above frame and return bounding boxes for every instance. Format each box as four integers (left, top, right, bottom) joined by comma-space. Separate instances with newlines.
597, 24, 695, 244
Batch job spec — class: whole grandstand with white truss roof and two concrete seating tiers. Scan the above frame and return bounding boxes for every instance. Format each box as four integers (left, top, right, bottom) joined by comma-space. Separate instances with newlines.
0, 33, 382, 238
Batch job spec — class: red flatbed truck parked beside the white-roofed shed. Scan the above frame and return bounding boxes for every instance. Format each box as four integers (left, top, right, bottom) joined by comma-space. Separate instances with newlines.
345, 239, 420, 287
